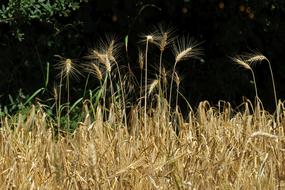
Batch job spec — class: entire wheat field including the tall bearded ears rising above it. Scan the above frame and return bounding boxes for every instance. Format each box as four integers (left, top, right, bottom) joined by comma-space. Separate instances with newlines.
0, 27, 285, 190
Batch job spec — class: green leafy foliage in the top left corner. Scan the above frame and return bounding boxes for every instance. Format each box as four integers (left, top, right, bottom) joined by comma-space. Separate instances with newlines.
0, 0, 88, 41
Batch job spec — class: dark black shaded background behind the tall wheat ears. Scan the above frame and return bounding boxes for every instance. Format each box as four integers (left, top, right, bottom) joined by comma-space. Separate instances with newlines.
0, 0, 285, 110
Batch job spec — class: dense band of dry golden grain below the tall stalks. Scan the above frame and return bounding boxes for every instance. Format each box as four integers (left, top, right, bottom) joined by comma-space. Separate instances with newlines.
0, 102, 285, 189
